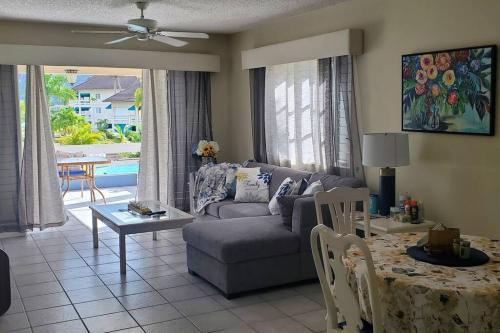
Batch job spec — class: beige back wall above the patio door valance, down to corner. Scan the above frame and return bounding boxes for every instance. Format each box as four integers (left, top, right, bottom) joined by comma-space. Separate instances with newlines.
0, 21, 230, 158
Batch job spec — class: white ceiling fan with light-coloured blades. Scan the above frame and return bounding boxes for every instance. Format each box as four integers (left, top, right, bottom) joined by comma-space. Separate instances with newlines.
71, 1, 209, 47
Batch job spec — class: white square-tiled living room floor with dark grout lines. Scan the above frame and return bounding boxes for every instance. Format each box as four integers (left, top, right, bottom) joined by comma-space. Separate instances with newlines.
0, 189, 326, 333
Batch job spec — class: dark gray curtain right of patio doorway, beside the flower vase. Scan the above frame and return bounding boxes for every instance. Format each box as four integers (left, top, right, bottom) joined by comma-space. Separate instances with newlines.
167, 71, 212, 211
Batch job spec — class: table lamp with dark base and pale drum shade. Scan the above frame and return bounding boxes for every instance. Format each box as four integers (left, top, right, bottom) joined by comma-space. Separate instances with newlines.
363, 133, 410, 216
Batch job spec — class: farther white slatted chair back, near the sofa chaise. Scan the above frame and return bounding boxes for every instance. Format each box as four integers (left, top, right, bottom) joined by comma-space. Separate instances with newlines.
314, 187, 371, 237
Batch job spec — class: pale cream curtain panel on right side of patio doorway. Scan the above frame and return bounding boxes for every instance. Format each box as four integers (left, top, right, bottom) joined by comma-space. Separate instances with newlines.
137, 69, 169, 202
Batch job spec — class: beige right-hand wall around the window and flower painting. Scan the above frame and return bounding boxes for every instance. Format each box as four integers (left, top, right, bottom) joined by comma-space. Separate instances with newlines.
229, 0, 500, 238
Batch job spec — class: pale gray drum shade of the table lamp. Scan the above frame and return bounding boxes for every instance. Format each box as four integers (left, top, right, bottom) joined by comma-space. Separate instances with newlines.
363, 133, 410, 168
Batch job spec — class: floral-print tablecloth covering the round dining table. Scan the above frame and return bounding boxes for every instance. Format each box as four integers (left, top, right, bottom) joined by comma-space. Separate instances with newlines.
346, 233, 500, 333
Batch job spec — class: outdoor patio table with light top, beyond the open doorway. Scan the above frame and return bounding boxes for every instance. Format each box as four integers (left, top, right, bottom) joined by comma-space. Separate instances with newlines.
57, 156, 111, 203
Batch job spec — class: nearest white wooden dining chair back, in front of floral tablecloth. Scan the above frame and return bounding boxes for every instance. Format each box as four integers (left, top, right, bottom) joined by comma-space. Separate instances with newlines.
311, 224, 382, 333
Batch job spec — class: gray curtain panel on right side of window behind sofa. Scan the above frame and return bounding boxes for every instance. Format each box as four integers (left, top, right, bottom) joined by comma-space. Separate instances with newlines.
318, 56, 365, 181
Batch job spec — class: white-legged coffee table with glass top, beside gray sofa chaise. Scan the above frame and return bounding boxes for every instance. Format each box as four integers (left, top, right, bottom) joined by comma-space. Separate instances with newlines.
90, 203, 194, 274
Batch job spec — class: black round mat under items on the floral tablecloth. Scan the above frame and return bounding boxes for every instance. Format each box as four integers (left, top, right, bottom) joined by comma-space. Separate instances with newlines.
406, 246, 490, 267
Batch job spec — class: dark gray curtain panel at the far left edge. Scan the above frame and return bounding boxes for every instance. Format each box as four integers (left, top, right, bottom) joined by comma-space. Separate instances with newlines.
0, 65, 25, 232
